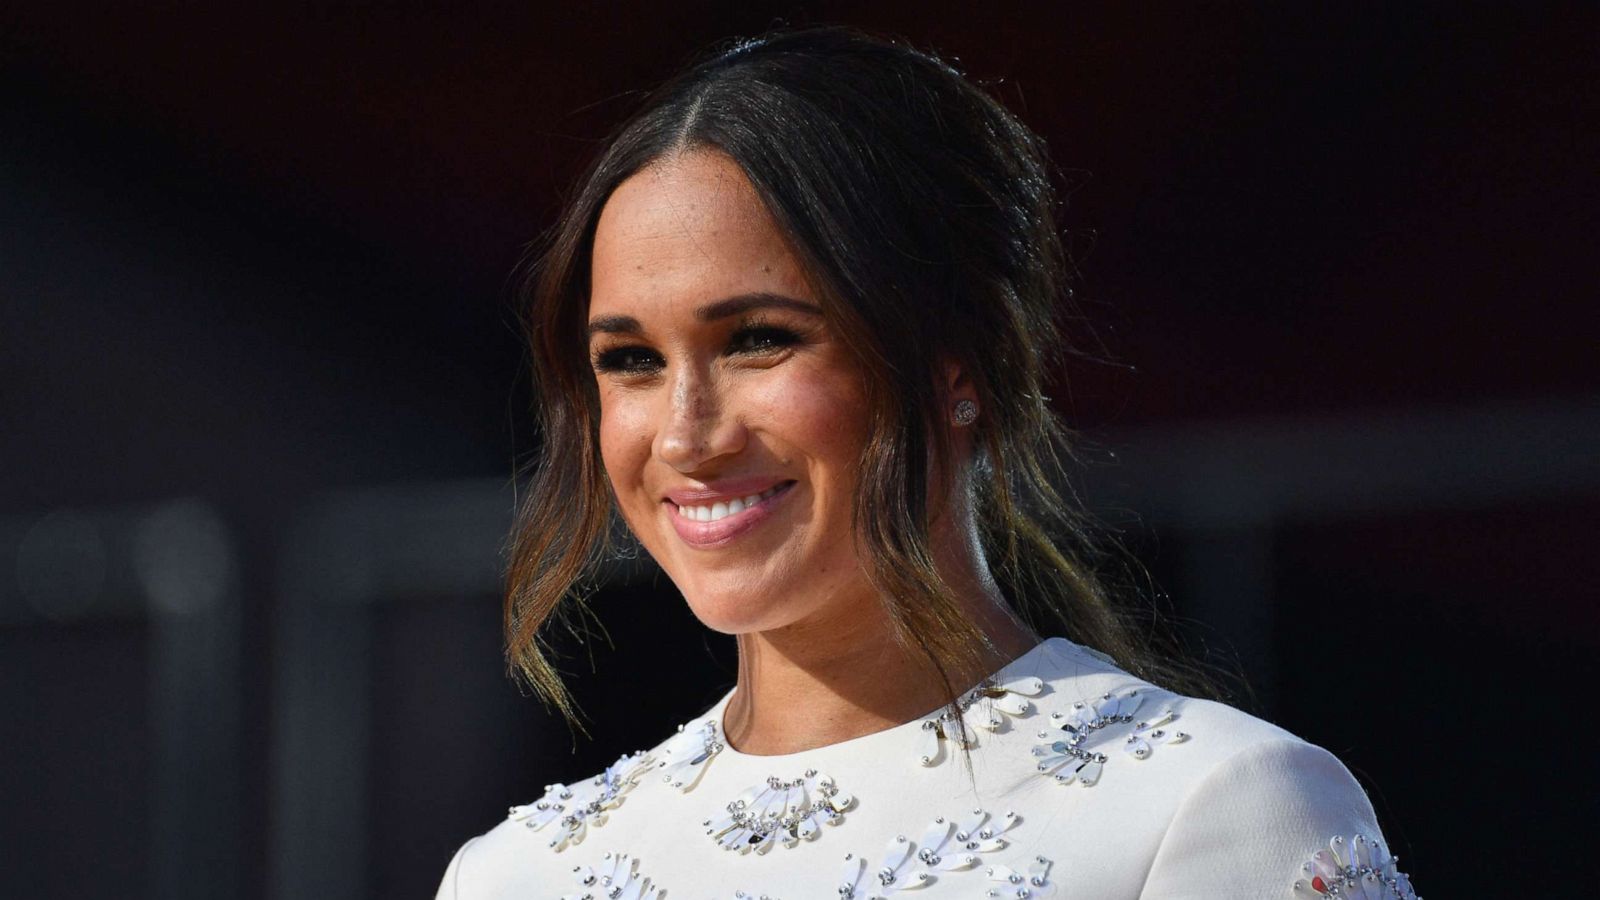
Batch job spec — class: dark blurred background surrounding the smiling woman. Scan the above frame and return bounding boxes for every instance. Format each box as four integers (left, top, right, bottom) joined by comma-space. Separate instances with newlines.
0, 3, 1600, 900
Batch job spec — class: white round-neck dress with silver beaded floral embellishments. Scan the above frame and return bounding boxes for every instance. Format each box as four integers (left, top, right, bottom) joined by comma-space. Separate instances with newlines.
438, 637, 1414, 900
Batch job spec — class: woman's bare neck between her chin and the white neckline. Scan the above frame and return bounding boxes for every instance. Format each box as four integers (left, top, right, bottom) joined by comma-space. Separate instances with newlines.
723, 576, 1038, 756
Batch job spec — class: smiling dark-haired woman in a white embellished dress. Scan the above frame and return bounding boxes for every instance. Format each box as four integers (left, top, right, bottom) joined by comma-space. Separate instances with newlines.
440, 29, 1411, 900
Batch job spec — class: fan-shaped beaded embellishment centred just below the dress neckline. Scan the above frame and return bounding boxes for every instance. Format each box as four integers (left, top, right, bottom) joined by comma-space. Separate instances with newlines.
702, 769, 856, 854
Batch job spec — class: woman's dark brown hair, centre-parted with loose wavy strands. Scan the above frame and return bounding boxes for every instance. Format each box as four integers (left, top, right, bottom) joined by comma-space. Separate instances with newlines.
506, 29, 1216, 716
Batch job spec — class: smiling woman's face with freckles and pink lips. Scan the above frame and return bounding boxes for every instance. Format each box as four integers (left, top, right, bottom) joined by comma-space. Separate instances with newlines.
588, 151, 869, 634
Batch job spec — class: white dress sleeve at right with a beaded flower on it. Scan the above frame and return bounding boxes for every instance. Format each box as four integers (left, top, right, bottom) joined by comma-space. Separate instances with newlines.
1141, 738, 1418, 900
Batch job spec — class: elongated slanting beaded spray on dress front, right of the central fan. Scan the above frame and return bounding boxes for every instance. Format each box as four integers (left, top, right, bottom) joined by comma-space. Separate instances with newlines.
837, 809, 1017, 900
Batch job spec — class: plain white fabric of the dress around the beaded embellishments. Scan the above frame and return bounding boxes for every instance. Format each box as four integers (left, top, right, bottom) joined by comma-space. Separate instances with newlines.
438, 637, 1387, 900
